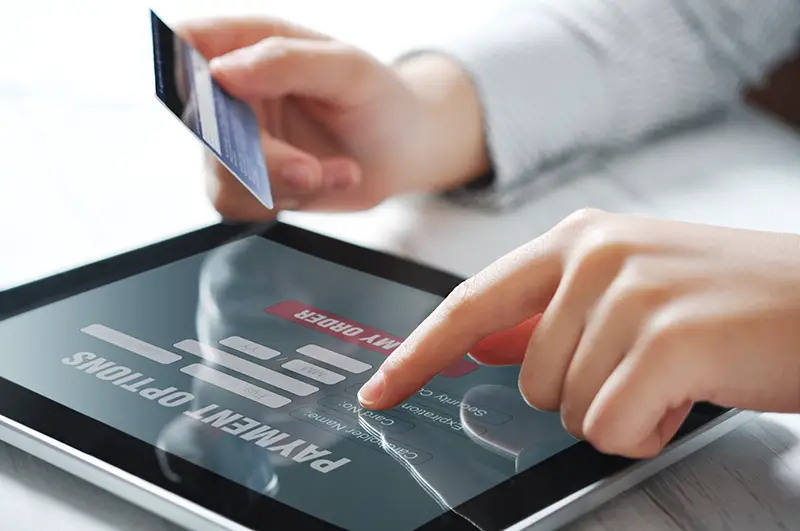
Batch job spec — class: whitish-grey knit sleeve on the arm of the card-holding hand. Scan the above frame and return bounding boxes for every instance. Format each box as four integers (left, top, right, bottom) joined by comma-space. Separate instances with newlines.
404, 0, 800, 210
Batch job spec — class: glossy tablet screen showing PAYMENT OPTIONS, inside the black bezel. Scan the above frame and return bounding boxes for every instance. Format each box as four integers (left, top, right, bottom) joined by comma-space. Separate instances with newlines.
0, 231, 576, 531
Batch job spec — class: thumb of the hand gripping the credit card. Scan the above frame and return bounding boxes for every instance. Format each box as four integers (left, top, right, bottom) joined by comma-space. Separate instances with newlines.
210, 37, 383, 107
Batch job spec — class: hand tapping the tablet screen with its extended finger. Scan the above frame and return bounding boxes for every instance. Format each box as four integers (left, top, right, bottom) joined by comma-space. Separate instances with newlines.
361, 211, 800, 458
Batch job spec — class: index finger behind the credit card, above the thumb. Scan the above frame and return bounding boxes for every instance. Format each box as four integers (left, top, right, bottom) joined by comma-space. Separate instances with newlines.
175, 17, 325, 59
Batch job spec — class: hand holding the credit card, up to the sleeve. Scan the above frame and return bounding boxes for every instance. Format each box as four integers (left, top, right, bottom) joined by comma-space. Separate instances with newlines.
178, 18, 488, 220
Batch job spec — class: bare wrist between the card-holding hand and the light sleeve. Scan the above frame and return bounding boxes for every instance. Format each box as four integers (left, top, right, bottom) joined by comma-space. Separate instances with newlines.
394, 53, 491, 192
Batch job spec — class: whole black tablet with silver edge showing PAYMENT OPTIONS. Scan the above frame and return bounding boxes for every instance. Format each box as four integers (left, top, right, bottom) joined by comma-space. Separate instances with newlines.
0, 222, 742, 531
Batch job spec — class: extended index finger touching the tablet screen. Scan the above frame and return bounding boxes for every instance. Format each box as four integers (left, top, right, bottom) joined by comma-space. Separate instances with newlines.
359, 235, 562, 409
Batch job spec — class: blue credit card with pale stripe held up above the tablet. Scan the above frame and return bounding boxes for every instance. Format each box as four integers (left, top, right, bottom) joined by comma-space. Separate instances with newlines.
150, 10, 273, 209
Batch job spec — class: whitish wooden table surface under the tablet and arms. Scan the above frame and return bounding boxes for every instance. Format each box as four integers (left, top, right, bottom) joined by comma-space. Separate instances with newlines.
0, 0, 800, 531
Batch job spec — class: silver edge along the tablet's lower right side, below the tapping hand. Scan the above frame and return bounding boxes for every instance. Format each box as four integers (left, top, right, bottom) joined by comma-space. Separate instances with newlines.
506, 409, 759, 531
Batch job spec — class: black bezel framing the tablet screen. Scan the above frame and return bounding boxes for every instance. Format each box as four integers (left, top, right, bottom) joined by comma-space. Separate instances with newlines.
0, 221, 729, 531
